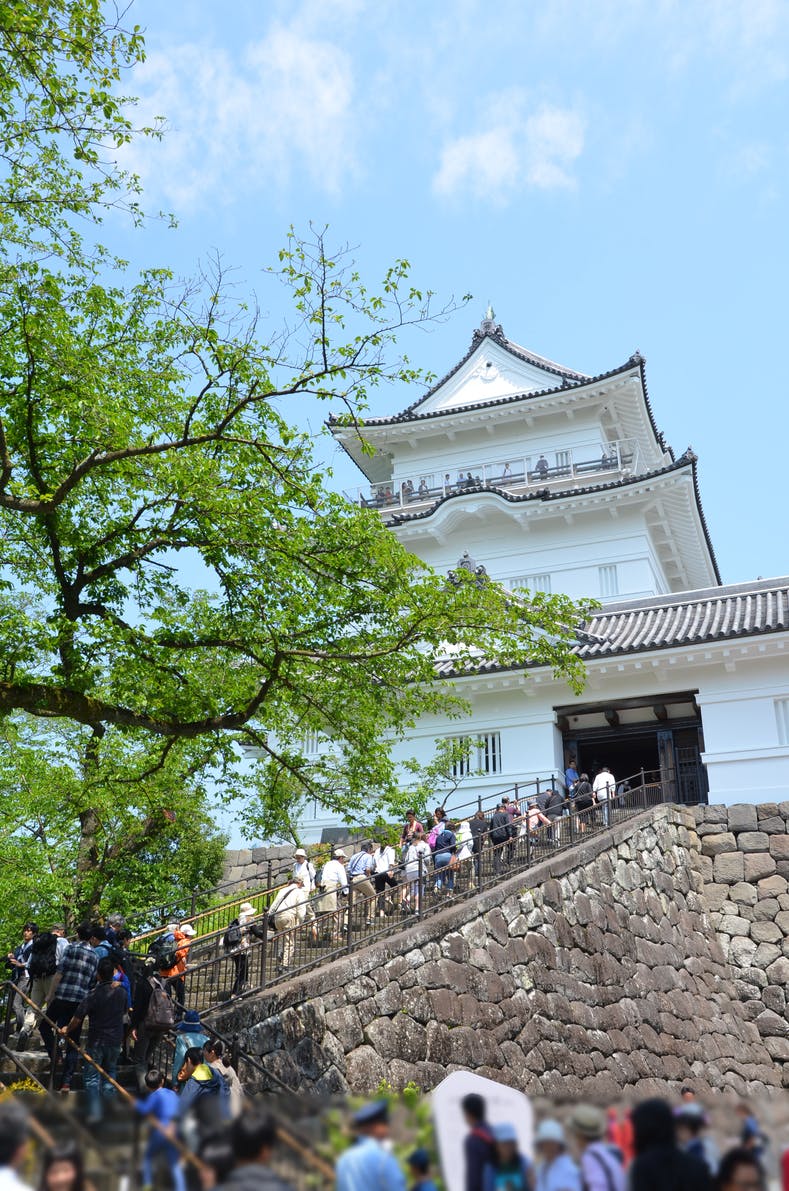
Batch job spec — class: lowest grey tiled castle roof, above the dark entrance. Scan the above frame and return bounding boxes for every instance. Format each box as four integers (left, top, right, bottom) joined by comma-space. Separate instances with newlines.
436, 576, 789, 678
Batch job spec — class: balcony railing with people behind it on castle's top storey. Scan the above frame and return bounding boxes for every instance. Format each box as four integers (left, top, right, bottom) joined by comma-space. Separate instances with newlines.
346, 438, 639, 516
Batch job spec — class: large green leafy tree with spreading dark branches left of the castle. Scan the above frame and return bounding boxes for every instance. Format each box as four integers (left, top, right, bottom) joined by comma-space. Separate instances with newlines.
0, 0, 593, 911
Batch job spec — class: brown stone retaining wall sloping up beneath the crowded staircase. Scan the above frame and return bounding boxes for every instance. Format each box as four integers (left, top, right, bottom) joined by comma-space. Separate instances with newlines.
217, 806, 789, 1102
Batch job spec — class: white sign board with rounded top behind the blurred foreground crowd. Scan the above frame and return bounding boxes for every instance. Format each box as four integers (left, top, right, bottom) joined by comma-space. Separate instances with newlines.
430, 1071, 534, 1191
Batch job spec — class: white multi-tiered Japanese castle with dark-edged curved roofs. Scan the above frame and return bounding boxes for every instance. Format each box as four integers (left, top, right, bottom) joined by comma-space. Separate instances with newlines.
302, 308, 789, 840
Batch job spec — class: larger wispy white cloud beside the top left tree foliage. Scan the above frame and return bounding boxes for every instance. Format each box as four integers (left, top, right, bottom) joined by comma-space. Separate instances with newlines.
128, 25, 356, 212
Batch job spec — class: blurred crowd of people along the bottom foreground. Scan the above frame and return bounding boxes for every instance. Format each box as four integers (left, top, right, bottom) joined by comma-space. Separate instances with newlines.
0, 1086, 789, 1191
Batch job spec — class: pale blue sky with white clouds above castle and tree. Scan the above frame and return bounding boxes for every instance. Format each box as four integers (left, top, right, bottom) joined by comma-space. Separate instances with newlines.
123, 0, 789, 581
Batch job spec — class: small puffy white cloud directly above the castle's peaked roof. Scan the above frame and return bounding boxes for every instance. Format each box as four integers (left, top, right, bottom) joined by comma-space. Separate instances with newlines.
433, 92, 585, 205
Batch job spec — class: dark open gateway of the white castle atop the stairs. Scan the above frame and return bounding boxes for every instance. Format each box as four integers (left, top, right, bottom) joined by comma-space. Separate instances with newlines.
555, 692, 708, 804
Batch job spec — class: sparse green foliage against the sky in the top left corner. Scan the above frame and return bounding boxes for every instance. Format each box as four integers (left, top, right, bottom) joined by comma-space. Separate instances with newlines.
0, 0, 161, 260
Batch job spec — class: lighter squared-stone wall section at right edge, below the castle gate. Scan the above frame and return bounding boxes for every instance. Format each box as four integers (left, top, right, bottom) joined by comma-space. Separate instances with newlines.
696, 802, 789, 1071
